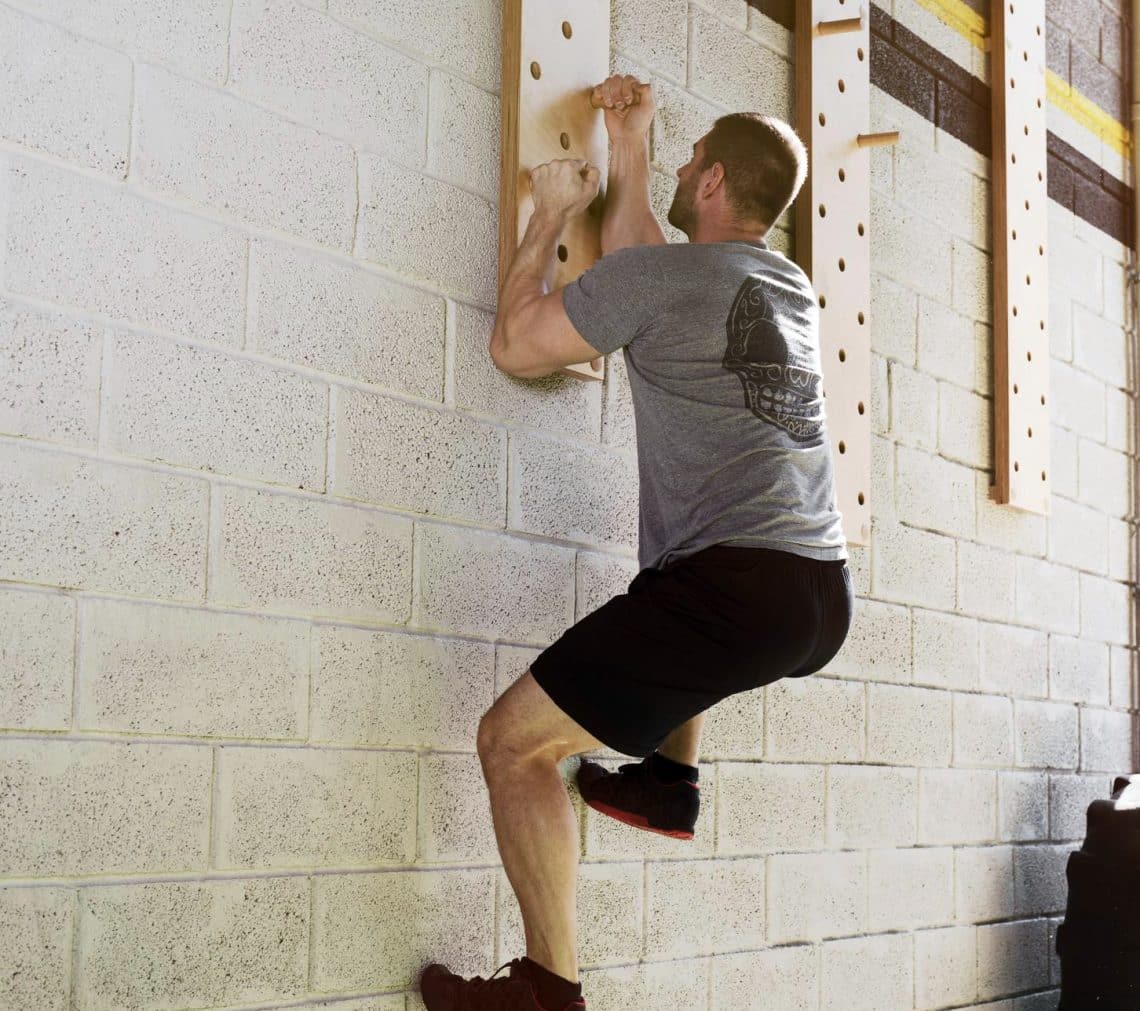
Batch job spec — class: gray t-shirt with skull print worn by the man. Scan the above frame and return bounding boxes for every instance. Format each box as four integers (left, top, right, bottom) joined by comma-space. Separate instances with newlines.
562, 240, 847, 569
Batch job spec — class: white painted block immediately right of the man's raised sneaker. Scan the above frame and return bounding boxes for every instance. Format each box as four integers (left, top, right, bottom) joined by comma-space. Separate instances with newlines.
702, 761, 824, 855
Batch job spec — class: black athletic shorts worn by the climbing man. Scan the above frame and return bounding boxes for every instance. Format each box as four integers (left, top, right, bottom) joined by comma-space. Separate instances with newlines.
530, 544, 855, 757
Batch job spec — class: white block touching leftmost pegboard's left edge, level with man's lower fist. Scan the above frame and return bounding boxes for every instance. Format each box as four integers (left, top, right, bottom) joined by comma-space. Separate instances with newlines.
355, 153, 498, 308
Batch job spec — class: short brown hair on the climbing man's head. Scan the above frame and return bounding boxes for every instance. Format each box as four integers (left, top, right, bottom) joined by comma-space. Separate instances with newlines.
701, 113, 807, 228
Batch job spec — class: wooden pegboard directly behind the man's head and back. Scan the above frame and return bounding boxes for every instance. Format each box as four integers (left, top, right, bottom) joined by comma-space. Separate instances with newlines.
796, 0, 871, 545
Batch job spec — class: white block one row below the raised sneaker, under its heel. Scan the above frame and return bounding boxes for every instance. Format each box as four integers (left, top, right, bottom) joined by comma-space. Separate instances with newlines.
637, 858, 764, 959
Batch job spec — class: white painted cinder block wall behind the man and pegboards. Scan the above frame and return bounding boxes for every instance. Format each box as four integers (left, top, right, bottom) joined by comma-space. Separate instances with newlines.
0, 0, 1134, 1011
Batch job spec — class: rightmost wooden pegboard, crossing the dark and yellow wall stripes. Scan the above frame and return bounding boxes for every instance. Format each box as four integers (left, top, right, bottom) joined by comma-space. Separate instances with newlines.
990, 0, 1050, 515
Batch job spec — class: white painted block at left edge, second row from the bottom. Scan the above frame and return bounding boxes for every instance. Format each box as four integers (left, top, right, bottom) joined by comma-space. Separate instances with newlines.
0, 739, 213, 878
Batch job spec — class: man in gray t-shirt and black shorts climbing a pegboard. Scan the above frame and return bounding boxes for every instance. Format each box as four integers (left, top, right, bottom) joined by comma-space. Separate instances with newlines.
421, 74, 854, 1011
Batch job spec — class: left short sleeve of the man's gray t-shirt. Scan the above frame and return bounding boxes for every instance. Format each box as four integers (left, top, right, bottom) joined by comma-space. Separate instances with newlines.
562, 245, 668, 354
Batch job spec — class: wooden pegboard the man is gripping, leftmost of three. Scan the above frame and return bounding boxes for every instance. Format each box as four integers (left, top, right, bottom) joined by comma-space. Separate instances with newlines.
498, 0, 610, 380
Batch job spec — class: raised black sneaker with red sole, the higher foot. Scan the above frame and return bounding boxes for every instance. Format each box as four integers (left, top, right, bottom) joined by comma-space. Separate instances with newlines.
578, 756, 701, 839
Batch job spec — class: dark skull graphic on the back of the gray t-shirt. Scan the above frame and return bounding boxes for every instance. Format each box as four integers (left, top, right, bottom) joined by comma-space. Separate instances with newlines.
722, 275, 824, 445
